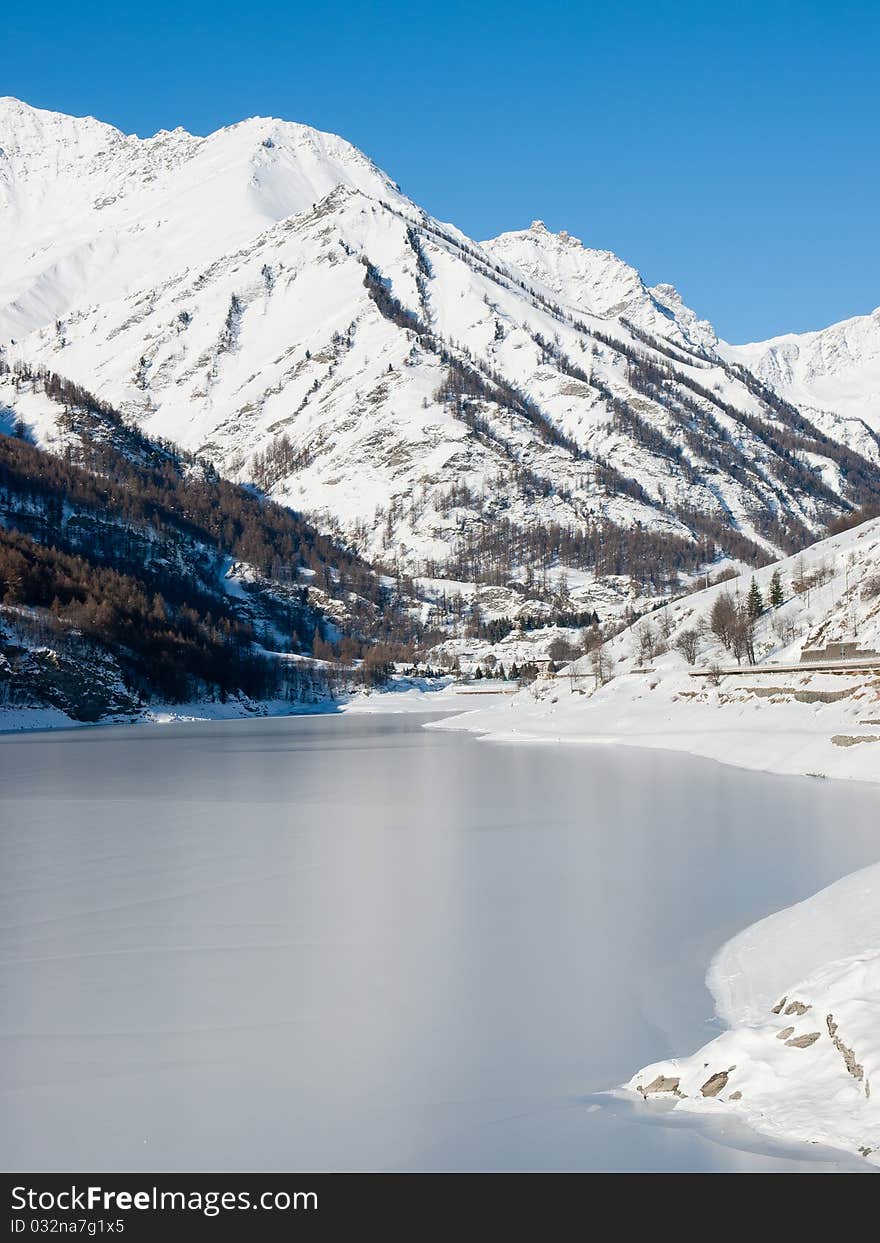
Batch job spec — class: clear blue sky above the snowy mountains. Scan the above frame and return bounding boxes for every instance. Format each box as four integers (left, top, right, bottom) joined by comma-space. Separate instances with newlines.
0, 0, 880, 341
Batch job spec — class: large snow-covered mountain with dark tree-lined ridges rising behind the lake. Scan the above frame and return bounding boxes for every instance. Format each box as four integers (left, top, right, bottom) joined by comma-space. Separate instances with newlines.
0, 99, 880, 621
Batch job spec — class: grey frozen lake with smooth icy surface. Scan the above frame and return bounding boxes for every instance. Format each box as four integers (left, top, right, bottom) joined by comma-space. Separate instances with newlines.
0, 716, 880, 1171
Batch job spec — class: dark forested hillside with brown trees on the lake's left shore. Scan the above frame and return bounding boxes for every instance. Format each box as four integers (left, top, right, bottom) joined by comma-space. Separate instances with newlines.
0, 363, 421, 718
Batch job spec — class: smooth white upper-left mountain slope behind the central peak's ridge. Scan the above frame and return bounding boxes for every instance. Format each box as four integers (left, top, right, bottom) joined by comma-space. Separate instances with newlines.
0, 97, 401, 341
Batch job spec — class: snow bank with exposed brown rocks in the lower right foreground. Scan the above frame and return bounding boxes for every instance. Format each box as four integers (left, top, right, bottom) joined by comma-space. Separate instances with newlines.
625, 864, 880, 1166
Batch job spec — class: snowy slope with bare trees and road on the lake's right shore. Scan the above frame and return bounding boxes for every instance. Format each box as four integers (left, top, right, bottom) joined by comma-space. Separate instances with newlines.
442, 518, 880, 782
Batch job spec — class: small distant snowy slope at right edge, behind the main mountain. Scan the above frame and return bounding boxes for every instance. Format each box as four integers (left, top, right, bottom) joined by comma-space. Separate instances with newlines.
718, 307, 880, 431
